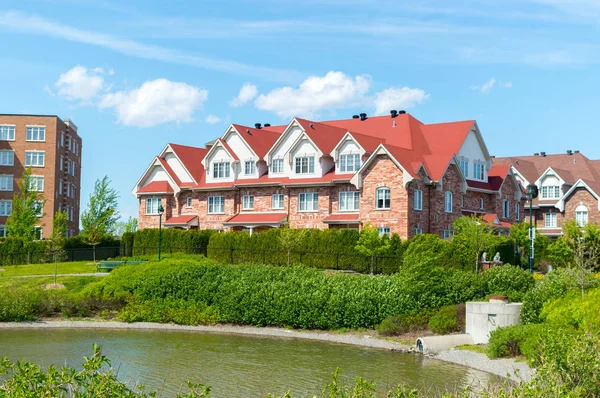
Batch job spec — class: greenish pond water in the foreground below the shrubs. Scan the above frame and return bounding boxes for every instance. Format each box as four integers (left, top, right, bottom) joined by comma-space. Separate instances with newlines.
0, 329, 497, 397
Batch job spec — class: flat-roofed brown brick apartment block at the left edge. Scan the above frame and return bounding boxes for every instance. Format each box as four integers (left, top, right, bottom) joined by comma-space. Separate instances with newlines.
0, 114, 82, 238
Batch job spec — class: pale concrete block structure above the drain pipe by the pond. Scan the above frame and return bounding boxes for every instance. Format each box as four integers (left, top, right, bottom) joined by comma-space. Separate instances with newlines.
466, 301, 522, 344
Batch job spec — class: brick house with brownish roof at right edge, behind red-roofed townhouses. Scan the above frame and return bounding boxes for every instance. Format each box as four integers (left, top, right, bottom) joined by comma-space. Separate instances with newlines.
493, 150, 600, 237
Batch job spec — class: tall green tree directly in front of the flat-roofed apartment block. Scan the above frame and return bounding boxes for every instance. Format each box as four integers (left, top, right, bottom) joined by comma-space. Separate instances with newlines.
6, 167, 45, 263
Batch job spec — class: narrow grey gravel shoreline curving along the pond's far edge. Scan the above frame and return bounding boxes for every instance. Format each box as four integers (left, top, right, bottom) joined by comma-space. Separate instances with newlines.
0, 319, 534, 382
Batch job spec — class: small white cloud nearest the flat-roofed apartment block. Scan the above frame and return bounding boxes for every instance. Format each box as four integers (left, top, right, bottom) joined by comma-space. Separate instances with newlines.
54, 65, 104, 101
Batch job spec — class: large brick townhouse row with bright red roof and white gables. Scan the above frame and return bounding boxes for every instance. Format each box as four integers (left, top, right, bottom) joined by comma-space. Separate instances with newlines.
133, 111, 523, 239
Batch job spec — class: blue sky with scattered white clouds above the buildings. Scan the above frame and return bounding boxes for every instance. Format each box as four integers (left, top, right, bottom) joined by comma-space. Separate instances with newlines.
0, 0, 600, 221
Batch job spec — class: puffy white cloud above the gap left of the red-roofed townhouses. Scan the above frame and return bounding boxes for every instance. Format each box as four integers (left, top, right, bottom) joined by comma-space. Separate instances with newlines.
99, 79, 208, 127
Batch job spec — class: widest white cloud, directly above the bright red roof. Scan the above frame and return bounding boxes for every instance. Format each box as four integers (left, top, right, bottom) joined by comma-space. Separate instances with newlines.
254, 71, 371, 118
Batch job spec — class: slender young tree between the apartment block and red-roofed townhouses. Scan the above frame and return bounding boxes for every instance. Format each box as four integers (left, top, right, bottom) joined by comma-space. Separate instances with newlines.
81, 176, 119, 262
